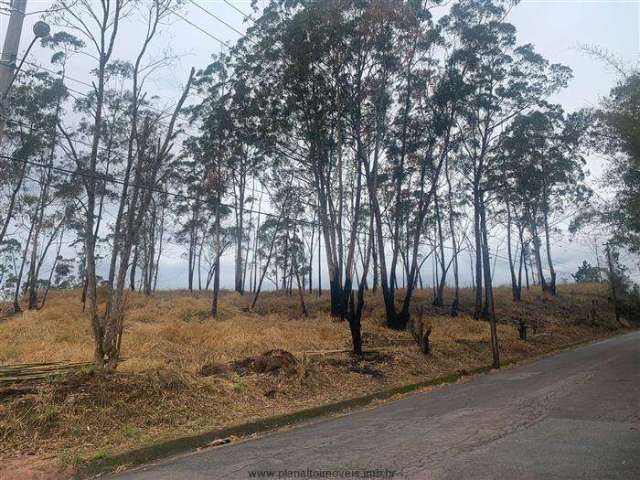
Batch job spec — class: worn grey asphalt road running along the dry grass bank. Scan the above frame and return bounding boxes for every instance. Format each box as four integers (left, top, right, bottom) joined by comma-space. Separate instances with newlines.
113, 332, 640, 480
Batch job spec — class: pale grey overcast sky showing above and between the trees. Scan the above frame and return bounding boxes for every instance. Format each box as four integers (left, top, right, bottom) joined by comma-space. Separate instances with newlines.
0, 0, 640, 288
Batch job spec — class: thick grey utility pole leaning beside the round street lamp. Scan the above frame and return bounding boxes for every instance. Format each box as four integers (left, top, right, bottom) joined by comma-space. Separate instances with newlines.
0, 0, 27, 142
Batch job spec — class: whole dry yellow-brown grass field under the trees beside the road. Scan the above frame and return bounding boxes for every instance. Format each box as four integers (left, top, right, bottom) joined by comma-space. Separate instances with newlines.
0, 284, 632, 476
